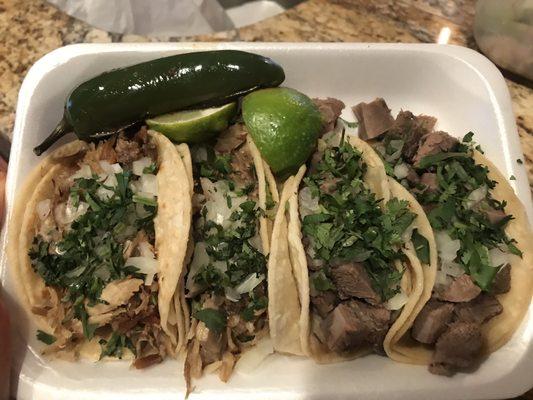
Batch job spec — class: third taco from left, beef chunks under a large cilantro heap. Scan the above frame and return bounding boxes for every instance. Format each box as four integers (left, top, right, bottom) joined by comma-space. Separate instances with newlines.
269, 120, 436, 363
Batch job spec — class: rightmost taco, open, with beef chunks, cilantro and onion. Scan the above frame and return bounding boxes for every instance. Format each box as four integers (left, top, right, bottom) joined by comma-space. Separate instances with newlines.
354, 99, 533, 375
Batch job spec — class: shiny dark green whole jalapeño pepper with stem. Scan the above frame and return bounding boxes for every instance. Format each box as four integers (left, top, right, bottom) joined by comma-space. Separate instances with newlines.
33, 50, 285, 155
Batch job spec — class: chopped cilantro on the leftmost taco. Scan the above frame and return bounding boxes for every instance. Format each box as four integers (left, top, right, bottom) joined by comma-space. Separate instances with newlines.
29, 171, 157, 339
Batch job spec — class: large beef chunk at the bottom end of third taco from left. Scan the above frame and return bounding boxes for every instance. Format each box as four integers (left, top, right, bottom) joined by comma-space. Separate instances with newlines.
322, 300, 390, 352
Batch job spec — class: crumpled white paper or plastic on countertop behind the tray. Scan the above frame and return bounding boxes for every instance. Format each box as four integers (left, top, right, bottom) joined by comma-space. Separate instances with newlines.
48, 0, 302, 37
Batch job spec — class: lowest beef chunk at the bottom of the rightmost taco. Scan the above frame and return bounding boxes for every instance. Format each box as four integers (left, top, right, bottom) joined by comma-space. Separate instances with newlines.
429, 322, 483, 376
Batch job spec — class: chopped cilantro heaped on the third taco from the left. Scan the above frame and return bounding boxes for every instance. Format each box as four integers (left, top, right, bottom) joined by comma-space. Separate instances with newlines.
302, 142, 416, 300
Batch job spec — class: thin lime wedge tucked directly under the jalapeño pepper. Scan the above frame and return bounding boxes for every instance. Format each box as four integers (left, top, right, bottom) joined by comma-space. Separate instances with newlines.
146, 103, 237, 143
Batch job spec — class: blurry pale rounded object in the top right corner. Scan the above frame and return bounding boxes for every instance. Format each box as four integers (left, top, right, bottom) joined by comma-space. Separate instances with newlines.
474, 0, 533, 80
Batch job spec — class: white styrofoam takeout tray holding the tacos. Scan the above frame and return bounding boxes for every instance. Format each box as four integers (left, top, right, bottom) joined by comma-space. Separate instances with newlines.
0, 43, 533, 400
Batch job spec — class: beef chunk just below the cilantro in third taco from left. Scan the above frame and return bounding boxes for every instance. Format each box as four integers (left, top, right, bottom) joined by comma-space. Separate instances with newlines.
331, 262, 381, 304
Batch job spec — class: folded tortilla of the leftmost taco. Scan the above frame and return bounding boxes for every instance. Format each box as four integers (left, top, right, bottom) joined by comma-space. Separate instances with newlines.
7, 132, 192, 367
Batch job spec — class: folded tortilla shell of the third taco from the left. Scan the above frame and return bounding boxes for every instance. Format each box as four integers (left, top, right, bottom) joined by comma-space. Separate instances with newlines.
269, 136, 437, 363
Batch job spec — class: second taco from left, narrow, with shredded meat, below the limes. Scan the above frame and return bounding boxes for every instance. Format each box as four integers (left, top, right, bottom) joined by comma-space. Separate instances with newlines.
184, 123, 278, 391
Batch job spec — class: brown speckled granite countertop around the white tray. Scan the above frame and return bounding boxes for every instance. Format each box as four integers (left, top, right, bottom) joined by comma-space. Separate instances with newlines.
0, 0, 533, 399
